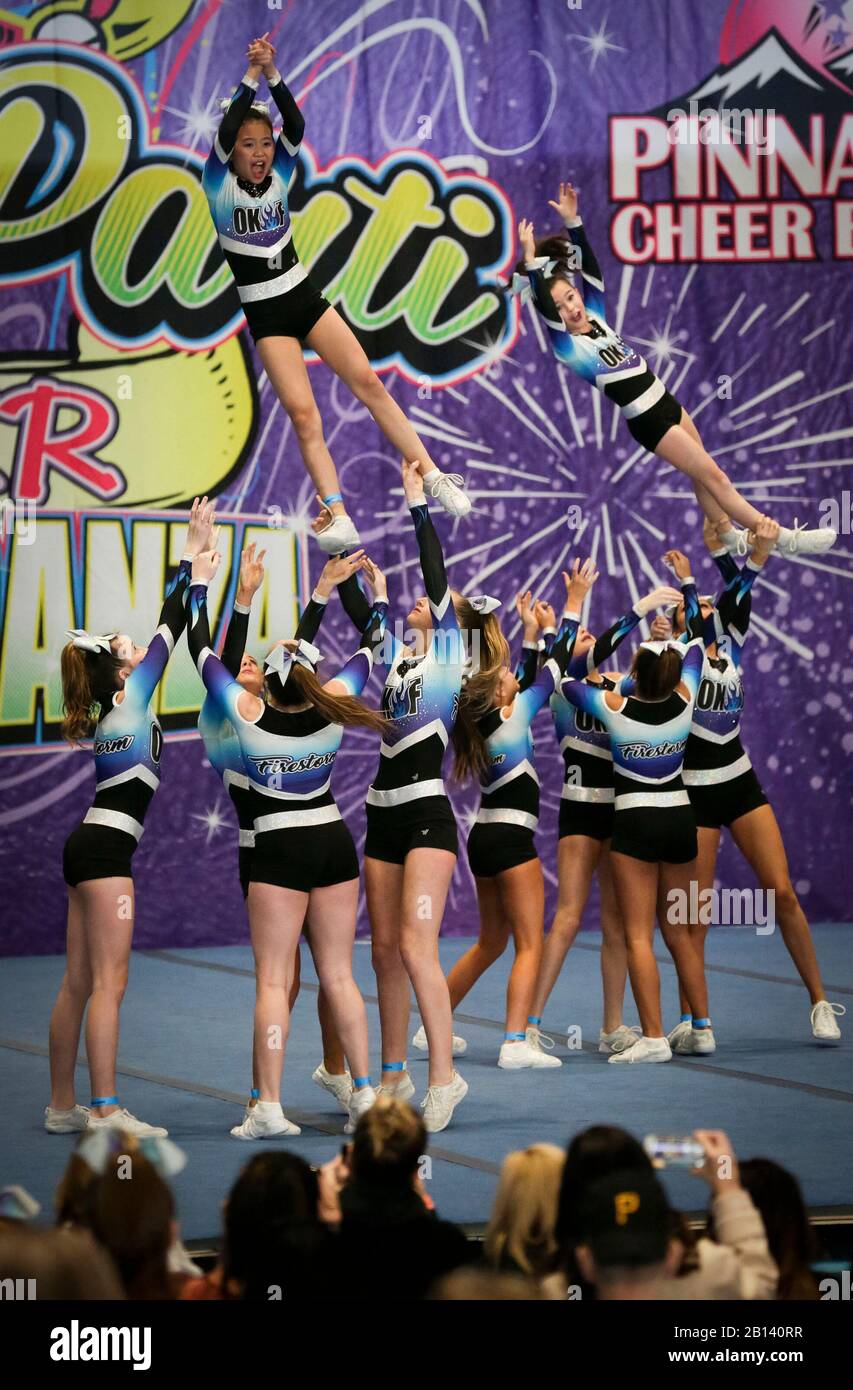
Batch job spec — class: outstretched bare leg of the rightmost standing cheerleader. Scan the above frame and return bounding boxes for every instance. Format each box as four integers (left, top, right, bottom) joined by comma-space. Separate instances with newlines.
729, 806, 825, 1004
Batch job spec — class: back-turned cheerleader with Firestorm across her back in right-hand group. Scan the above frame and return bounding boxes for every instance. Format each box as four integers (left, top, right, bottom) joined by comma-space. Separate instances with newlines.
563, 550, 710, 1063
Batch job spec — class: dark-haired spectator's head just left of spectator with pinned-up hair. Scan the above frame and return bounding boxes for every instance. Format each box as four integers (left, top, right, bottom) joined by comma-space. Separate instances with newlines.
224, 1150, 321, 1300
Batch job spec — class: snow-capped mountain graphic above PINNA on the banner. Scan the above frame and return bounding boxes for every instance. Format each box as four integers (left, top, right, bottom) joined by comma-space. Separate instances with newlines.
649, 29, 853, 147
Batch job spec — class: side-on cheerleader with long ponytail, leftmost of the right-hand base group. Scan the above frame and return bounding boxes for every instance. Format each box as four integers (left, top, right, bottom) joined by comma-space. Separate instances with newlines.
447, 560, 597, 1070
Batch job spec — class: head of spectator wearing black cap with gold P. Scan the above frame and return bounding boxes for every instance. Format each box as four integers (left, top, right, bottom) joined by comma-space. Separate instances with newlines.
577, 1168, 681, 1294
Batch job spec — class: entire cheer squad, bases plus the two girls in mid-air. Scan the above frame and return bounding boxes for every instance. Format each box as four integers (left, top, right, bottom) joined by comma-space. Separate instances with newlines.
44, 35, 845, 1140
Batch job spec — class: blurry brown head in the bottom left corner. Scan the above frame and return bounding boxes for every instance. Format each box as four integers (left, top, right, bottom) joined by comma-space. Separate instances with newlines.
0, 1222, 125, 1301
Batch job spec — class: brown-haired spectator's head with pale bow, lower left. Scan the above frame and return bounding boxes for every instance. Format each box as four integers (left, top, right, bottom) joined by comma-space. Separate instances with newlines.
81, 1130, 176, 1300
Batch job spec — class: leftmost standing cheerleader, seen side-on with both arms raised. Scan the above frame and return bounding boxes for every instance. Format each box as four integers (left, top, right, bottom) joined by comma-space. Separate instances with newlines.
44, 498, 214, 1137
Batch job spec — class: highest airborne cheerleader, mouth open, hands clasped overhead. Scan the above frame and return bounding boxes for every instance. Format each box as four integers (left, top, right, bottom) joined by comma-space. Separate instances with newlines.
201, 35, 471, 553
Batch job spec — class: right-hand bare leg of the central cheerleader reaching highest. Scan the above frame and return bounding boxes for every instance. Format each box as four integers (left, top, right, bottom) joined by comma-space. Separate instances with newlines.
400, 849, 456, 1086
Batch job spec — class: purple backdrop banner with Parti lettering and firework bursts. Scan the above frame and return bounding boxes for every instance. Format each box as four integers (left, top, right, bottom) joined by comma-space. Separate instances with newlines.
0, 0, 853, 954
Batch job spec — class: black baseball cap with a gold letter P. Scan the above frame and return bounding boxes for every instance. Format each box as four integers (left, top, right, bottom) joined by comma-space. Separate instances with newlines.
579, 1168, 670, 1268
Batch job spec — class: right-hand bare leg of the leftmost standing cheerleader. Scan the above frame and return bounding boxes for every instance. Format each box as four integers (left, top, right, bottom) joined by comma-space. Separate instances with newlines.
76, 878, 135, 1116
